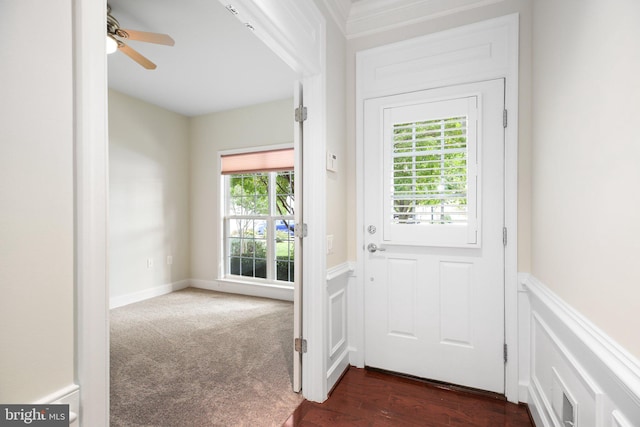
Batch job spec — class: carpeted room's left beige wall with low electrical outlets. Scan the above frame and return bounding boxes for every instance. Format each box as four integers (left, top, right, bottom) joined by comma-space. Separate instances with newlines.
109, 90, 191, 298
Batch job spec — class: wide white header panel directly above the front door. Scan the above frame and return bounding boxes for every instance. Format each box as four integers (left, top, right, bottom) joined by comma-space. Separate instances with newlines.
356, 15, 518, 99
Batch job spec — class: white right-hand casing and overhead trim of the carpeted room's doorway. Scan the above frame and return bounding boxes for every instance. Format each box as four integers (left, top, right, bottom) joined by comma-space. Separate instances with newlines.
219, 0, 327, 402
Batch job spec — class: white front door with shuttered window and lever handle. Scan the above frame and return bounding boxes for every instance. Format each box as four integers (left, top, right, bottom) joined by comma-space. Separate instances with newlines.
363, 79, 504, 393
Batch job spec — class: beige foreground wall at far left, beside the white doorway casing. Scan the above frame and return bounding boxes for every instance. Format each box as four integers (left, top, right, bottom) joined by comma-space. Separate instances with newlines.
0, 0, 74, 403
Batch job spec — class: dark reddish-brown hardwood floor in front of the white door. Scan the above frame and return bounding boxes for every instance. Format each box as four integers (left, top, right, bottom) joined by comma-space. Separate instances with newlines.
283, 367, 533, 427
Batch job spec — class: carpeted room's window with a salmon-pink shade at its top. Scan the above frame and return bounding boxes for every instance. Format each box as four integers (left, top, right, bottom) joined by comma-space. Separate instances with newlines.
221, 149, 295, 284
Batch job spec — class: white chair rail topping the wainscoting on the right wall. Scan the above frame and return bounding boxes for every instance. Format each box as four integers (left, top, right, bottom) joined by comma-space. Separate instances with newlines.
523, 276, 640, 407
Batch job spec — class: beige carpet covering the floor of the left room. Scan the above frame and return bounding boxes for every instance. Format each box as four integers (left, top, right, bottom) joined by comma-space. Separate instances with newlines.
111, 288, 302, 427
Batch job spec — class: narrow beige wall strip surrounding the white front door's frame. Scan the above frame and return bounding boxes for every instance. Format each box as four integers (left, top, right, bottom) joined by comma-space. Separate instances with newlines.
347, 0, 531, 271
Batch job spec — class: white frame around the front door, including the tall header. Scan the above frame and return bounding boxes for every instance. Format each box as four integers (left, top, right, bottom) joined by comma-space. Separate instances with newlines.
350, 14, 519, 402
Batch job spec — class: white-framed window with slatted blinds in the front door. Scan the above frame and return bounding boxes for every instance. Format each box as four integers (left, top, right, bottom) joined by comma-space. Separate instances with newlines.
383, 96, 480, 247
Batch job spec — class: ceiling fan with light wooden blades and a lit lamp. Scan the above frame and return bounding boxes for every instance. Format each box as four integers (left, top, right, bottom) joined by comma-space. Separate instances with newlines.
107, 4, 175, 70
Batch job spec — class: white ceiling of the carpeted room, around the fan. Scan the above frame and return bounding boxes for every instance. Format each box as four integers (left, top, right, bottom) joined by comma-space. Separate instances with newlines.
108, 0, 296, 116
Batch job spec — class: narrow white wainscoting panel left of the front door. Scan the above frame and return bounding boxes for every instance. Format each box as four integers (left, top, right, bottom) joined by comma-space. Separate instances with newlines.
327, 263, 353, 390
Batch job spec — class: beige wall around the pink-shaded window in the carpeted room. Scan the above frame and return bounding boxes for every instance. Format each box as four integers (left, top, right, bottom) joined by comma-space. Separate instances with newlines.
190, 99, 293, 280
